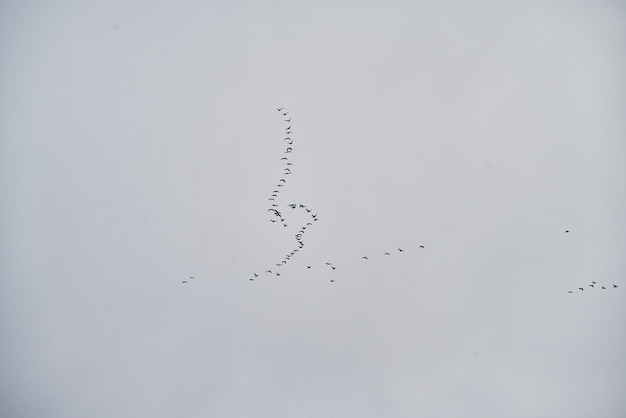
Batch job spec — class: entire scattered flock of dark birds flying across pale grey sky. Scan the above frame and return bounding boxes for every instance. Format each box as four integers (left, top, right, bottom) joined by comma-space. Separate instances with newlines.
182, 107, 618, 293
